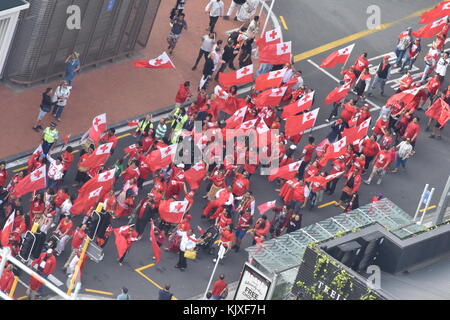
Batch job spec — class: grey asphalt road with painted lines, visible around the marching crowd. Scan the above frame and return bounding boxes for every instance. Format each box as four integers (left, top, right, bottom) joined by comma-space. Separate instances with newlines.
6, 0, 450, 299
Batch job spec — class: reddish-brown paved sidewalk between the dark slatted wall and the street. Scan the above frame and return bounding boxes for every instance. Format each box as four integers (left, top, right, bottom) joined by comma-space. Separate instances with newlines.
0, 0, 270, 159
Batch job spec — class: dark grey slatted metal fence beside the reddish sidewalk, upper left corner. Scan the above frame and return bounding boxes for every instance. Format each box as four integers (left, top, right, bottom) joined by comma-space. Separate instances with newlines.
5, 0, 161, 84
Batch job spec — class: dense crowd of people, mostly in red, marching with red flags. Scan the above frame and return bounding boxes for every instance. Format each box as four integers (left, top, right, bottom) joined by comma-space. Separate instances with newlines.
0, 0, 450, 299
